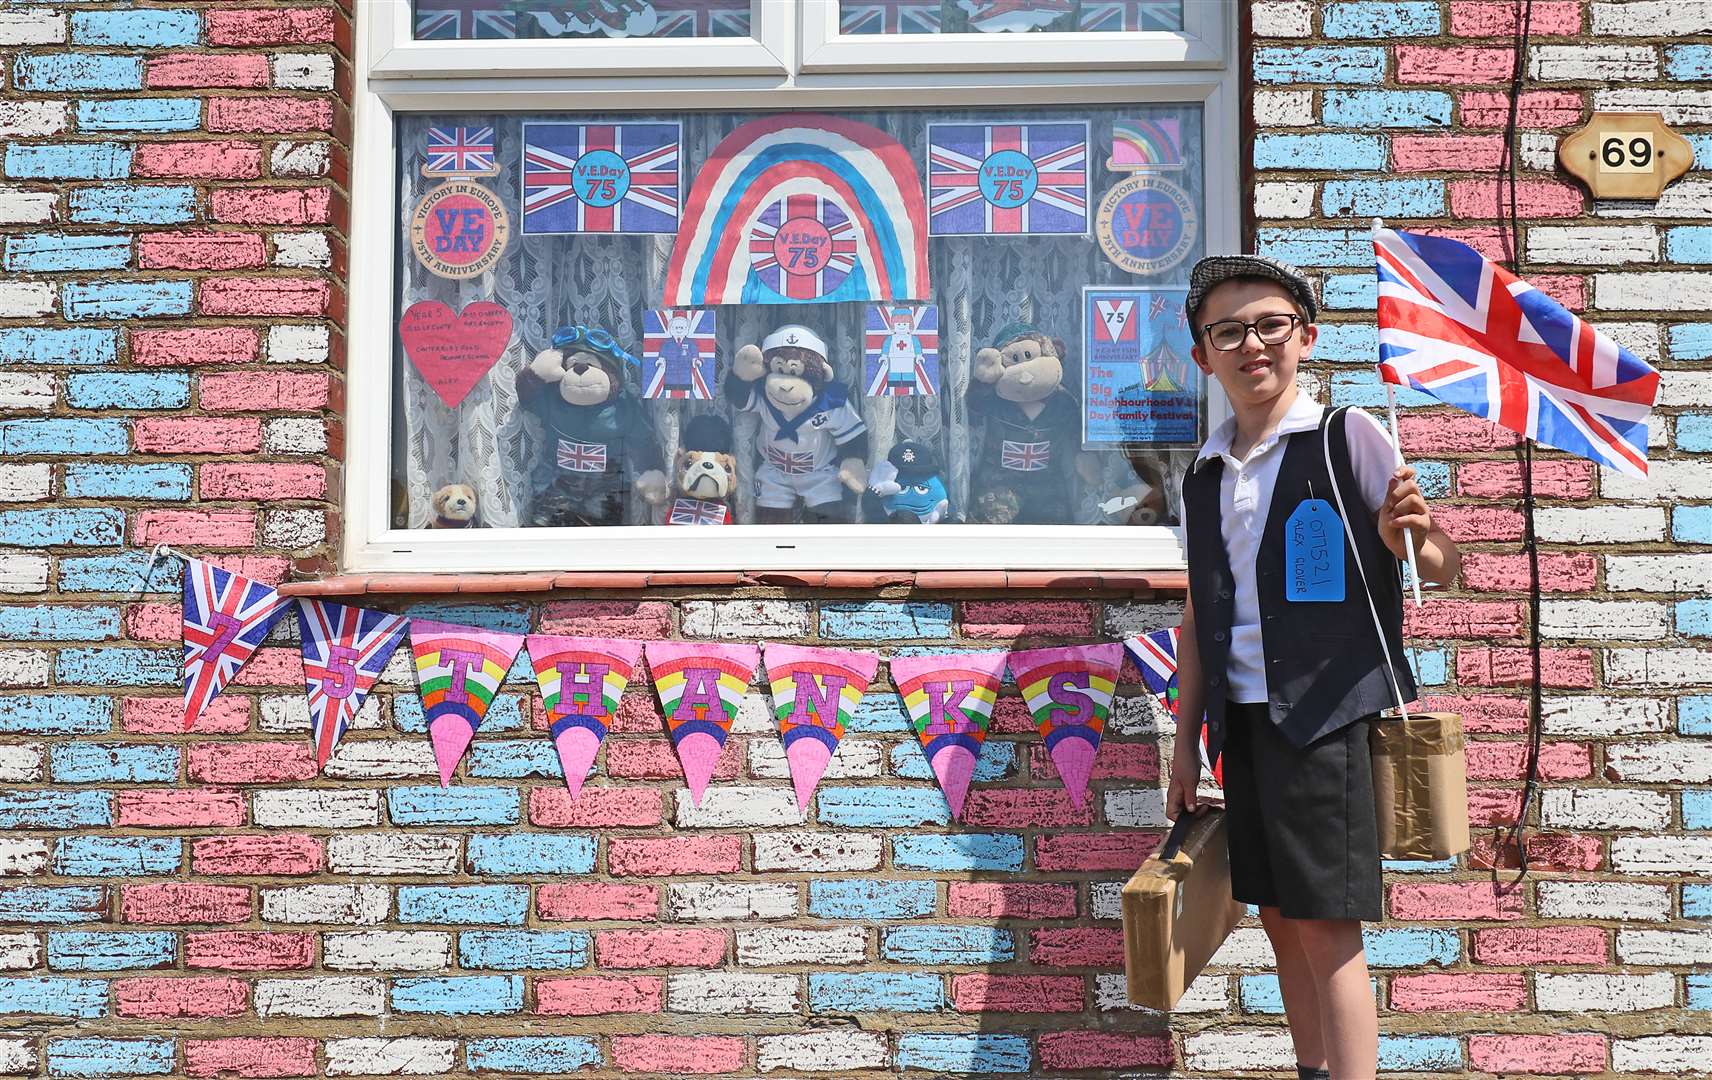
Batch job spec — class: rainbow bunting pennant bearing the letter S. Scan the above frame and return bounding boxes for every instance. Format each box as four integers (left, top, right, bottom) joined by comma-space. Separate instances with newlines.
1010, 642, 1123, 810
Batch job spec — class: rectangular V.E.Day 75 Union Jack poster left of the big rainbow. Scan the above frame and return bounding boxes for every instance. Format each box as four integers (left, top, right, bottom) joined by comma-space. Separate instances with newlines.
522, 123, 683, 236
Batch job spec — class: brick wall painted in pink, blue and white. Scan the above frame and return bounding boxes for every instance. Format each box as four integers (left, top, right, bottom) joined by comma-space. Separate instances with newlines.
0, 0, 1712, 1077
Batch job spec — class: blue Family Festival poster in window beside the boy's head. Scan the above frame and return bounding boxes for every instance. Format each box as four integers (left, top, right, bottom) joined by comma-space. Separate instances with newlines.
1082, 286, 1202, 448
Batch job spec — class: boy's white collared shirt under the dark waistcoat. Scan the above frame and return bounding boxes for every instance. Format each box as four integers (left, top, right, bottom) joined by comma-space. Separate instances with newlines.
1178, 394, 1397, 702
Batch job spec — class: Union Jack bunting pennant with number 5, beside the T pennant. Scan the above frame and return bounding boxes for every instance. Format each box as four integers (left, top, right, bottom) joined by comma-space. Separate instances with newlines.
298, 597, 409, 767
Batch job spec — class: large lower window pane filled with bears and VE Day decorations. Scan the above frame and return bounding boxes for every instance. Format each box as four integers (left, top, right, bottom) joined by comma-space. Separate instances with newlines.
392, 104, 1205, 529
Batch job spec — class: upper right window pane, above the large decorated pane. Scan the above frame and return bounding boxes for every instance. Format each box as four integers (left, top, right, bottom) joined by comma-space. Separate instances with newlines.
839, 0, 1185, 34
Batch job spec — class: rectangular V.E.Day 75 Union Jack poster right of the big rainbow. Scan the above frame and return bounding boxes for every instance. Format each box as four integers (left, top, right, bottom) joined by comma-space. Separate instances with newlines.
928, 123, 1087, 236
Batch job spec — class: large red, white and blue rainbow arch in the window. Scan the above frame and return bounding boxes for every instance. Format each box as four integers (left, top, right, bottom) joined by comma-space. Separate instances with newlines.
661, 113, 931, 308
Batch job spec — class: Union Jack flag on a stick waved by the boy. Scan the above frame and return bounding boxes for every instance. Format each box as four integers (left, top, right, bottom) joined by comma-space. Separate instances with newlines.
1373, 228, 1659, 476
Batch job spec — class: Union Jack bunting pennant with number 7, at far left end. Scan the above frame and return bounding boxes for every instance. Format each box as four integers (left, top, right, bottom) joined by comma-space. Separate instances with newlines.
183, 558, 291, 731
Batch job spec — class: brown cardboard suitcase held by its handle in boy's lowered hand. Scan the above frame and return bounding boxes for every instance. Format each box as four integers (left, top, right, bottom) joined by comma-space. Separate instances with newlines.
1123, 810, 1246, 1012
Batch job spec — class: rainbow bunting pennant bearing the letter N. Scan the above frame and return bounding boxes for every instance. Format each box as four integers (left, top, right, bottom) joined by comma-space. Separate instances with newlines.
762, 645, 880, 810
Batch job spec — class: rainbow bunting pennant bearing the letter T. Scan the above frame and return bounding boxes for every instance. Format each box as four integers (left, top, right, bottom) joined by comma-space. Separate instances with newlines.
411, 620, 524, 787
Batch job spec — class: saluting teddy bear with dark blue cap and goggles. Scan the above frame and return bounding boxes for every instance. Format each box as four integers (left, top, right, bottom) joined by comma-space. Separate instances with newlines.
517, 325, 671, 525
